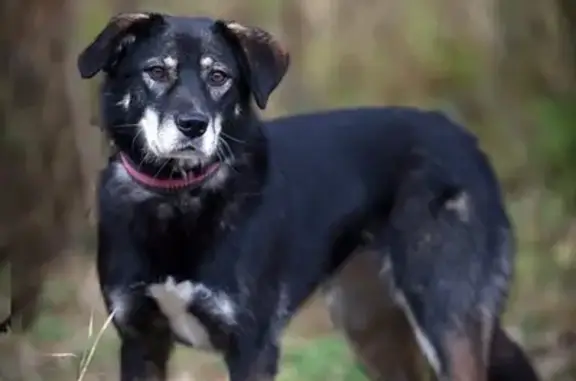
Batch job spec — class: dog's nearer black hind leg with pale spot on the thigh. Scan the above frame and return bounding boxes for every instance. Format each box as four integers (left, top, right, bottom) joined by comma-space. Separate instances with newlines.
374, 179, 513, 381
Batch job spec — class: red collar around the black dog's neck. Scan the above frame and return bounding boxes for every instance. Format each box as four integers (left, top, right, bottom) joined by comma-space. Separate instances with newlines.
120, 153, 220, 191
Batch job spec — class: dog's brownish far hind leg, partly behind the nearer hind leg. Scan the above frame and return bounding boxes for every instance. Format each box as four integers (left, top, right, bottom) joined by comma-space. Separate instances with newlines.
324, 251, 431, 381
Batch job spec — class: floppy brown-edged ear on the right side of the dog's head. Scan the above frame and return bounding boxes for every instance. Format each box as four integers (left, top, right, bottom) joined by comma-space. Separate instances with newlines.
216, 20, 290, 109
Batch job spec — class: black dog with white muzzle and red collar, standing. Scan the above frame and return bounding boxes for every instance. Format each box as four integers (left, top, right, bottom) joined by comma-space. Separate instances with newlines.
78, 13, 530, 381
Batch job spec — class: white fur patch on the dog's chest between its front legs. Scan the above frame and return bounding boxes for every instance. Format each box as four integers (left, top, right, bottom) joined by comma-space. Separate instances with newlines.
148, 277, 236, 350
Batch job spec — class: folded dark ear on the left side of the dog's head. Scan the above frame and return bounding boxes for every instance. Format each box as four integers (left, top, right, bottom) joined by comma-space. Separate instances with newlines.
78, 13, 162, 78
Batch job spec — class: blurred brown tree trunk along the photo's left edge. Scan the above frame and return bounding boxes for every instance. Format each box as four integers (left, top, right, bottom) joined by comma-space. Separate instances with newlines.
0, 0, 83, 380
